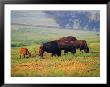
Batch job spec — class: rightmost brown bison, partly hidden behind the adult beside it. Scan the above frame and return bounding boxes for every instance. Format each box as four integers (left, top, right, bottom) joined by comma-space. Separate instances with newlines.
70, 40, 89, 53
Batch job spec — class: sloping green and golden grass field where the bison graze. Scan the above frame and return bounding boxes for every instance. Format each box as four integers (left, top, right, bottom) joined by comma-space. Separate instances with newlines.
11, 25, 100, 77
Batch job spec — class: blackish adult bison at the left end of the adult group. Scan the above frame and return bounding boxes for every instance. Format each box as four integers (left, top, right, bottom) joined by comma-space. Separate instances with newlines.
39, 40, 61, 57
